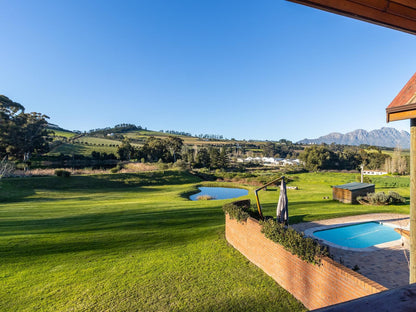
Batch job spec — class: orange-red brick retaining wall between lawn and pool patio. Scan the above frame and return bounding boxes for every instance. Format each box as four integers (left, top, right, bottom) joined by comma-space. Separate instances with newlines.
225, 214, 387, 309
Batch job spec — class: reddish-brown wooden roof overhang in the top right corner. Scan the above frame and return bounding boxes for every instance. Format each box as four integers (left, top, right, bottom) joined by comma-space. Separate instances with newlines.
288, 0, 416, 35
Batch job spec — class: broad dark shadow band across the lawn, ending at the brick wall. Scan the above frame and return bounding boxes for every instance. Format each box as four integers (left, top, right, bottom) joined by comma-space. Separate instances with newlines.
0, 207, 224, 262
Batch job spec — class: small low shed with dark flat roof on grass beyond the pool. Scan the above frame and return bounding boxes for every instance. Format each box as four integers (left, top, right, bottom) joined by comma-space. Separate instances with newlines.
332, 182, 375, 204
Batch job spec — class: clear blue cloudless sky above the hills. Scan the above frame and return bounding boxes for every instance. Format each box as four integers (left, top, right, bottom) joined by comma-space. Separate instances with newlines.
0, 0, 416, 141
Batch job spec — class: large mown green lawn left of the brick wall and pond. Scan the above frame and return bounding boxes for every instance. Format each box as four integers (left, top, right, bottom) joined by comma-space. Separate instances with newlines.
0, 171, 304, 311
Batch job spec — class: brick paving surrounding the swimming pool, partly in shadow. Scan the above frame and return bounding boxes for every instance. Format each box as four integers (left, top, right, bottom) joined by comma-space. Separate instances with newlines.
292, 213, 409, 289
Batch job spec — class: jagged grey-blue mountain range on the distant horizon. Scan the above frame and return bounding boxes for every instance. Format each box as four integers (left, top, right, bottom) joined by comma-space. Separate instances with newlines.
298, 127, 410, 149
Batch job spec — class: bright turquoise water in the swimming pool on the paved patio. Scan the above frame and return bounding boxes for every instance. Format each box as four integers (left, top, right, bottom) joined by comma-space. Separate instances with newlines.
313, 222, 401, 248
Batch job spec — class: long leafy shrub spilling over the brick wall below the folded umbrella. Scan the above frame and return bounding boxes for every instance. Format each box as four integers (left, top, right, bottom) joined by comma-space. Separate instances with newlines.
260, 219, 329, 264
